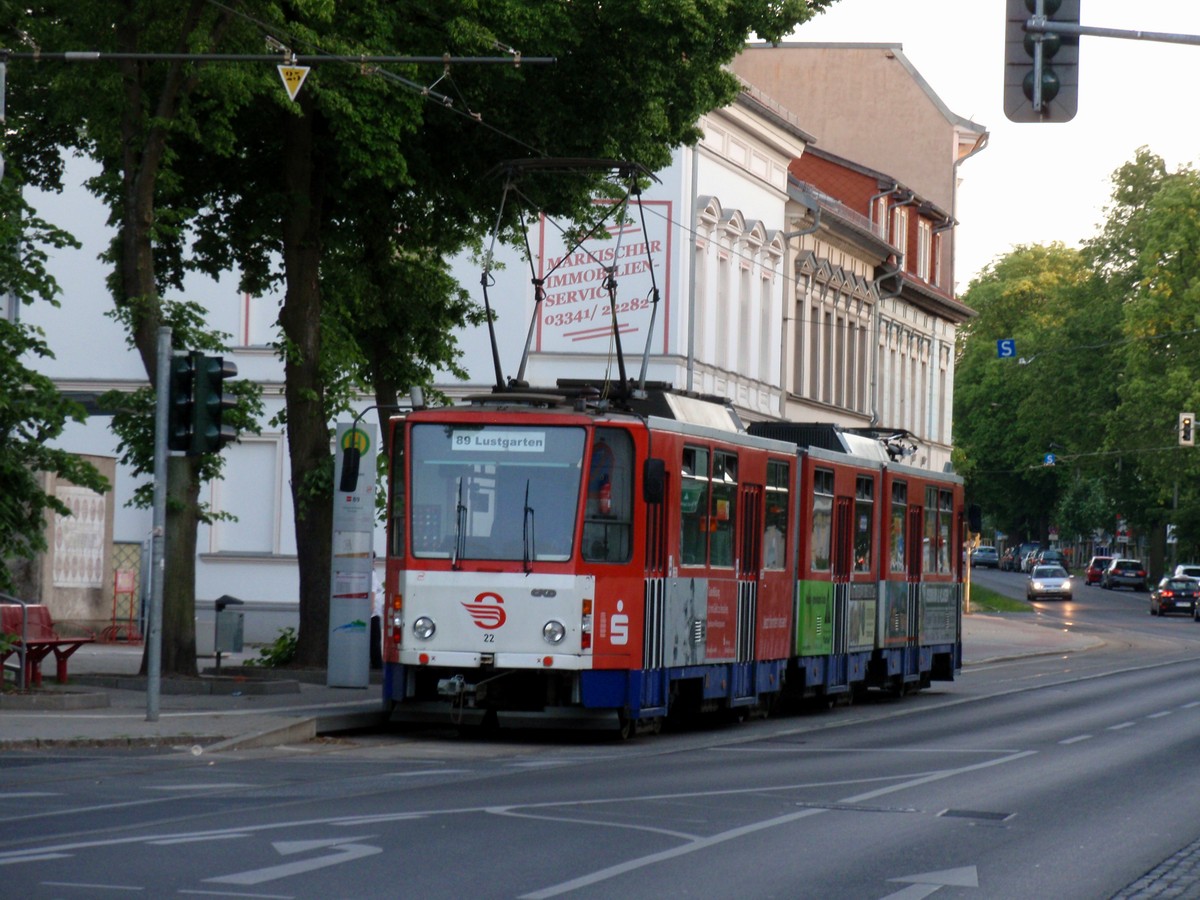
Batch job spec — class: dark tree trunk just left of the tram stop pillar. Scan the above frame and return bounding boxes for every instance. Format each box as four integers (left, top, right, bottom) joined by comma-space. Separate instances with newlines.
280, 95, 334, 666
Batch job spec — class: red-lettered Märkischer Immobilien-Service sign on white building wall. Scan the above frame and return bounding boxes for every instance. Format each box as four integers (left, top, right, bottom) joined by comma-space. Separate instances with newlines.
534, 200, 673, 353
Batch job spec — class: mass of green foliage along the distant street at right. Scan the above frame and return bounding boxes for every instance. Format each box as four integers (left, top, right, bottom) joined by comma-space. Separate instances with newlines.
955, 148, 1200, 557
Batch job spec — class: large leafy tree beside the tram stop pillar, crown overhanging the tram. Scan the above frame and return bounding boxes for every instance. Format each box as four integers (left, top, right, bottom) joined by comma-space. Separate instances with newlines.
177, 0, 828, 665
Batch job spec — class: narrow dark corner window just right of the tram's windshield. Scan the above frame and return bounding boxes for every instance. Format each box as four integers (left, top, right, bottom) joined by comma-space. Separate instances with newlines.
583, 428, 634, 563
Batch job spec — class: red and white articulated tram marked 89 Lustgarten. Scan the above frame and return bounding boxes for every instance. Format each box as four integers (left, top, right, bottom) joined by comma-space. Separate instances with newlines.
384, 390, 965, 732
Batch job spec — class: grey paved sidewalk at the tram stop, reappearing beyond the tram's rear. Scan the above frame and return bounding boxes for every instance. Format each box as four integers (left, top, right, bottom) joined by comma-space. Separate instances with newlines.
0, 613, 1102, 755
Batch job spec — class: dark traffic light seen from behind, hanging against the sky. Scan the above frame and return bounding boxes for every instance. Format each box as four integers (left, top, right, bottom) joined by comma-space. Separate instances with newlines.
1004, 0, 1080, 122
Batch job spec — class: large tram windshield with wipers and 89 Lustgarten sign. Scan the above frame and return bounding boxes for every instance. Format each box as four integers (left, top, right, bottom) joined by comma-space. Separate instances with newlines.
409, 424, 586, 563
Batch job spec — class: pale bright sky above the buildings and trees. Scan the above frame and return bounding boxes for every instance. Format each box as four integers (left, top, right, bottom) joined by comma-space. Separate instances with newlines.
788, 0, 1200, 293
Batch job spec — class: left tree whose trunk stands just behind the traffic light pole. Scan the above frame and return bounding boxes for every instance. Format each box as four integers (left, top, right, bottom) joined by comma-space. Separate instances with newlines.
4, 0, 265, 674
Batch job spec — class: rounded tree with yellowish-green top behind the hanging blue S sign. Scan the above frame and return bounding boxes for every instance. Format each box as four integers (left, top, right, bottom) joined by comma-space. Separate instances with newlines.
954, 244, 1120, 541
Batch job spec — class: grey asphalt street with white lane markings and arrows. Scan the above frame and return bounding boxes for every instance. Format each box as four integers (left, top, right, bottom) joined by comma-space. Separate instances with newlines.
0, 571, 1200, 898
